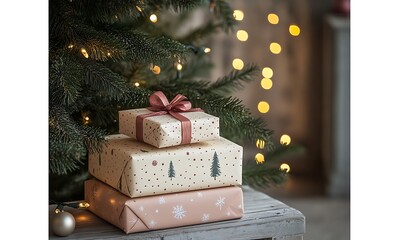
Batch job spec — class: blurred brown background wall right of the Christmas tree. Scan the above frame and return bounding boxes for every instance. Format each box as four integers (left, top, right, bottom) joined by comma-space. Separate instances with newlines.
211, 0, 350, 199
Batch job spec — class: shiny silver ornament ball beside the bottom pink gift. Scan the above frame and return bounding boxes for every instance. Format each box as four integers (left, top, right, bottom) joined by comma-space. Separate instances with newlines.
52, 211, 76, 237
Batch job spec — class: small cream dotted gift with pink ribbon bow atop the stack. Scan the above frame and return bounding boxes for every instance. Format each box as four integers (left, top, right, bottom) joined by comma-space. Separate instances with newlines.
119, 91, 220, 148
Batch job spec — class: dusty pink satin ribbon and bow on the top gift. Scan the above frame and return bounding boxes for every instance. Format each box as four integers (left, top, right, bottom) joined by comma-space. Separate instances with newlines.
136, 91, 203, 144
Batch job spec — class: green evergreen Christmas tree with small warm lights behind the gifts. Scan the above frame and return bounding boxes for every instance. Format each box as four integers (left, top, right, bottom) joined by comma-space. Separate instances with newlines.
49, 0, 304, 201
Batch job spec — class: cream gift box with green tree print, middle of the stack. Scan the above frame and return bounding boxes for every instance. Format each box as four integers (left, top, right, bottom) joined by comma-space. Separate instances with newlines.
88, 134, 243, 198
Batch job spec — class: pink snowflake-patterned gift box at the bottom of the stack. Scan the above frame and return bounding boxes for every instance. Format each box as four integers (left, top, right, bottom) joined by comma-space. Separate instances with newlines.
85, 179, 244, 234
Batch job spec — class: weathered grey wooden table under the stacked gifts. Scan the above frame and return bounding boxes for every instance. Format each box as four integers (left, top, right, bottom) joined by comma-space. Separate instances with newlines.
49, 186, 305, 240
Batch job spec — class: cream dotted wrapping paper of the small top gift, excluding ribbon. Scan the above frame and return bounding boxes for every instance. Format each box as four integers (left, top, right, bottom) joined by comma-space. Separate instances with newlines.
119, 108, 220, 148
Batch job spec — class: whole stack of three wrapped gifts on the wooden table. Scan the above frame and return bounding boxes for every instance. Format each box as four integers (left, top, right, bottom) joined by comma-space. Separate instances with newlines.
85, 91, 244, 234
